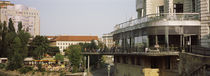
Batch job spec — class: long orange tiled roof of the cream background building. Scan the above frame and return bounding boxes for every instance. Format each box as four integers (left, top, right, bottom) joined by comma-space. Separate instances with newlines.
47, 36, 98, 41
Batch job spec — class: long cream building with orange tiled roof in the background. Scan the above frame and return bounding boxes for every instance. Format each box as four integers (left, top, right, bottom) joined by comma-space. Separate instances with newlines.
47, 36, 98, 54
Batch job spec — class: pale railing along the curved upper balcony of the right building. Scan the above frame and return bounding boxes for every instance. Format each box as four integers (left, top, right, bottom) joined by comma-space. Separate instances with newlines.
115, 13, 200, 30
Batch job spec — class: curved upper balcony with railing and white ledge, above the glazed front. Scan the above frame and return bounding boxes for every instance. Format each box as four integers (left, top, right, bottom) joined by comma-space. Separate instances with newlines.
113, 13, 200, 34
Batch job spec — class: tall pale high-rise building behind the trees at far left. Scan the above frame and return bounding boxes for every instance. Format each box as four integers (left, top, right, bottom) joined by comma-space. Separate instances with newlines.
0, 1, 40, 36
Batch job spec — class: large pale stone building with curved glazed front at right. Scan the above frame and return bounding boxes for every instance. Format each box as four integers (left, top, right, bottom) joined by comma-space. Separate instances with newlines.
110, 0, 209, 76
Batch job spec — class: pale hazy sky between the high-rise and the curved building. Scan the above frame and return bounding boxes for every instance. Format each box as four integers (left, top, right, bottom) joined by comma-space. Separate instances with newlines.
8, 0, 137, 36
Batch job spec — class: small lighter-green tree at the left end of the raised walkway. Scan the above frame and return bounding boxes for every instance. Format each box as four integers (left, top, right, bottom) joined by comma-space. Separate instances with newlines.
67, 45, 82, 73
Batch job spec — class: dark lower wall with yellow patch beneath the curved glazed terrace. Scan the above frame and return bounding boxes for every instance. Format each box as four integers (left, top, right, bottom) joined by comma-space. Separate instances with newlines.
115, 56, 178, 76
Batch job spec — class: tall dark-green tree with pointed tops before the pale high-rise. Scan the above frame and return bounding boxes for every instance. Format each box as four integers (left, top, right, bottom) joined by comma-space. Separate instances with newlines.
5, 19, 30, 70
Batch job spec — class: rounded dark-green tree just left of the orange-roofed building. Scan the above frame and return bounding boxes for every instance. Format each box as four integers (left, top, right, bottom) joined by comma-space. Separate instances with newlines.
29, 36, 50, 59
